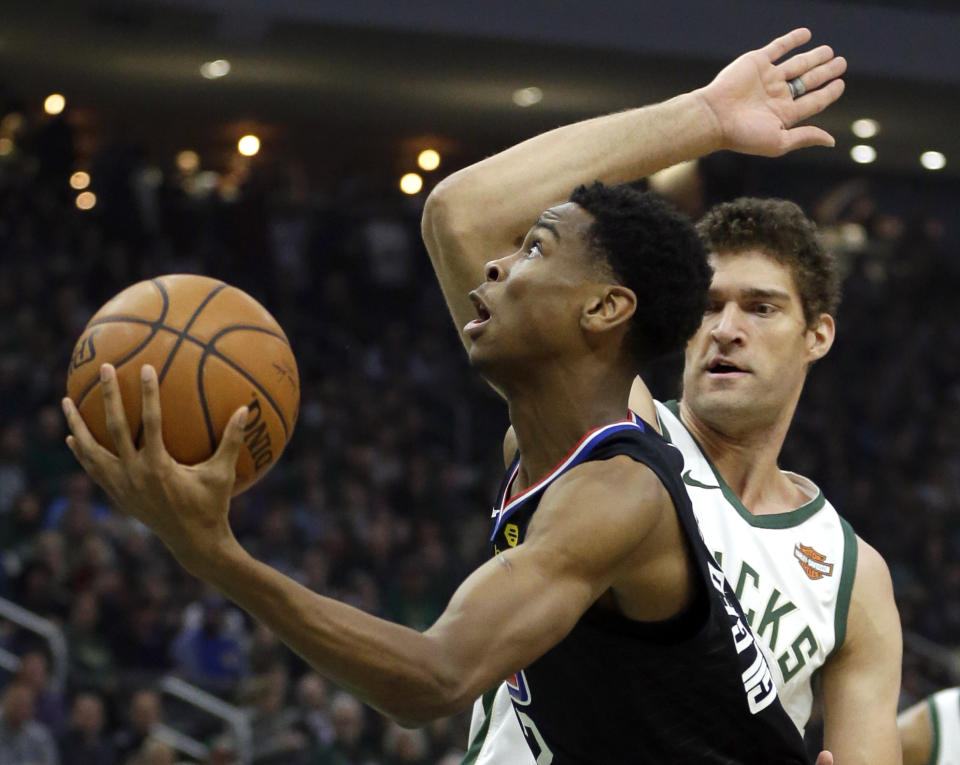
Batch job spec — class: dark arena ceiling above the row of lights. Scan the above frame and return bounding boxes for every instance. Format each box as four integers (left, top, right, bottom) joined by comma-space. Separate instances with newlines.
0, 0, 960, 176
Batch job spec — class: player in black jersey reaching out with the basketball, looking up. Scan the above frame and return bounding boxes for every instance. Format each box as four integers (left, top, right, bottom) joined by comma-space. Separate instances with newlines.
63, 26, 830, 765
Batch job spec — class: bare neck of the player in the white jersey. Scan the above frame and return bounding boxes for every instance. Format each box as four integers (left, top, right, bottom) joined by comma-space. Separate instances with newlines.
680, 401, 808, 515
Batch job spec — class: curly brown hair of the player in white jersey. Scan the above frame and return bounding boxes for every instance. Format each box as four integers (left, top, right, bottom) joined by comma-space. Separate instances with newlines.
697, 197, 840, 327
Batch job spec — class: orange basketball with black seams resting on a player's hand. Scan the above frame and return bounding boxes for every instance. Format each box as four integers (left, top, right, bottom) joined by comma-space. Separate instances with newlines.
67, 274, 300, 495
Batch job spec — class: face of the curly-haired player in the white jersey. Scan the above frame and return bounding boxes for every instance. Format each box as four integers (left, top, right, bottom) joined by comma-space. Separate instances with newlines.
683, 250, 834, 436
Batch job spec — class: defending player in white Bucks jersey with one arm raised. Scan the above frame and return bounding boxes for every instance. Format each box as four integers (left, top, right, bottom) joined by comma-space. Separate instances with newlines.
424, 29, 901, 765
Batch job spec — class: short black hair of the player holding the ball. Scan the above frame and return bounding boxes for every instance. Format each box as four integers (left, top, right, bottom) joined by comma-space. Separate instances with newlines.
570, 181, 712, 367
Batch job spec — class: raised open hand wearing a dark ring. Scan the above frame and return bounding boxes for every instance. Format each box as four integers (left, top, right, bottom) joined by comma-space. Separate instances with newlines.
697, 28, 847, 157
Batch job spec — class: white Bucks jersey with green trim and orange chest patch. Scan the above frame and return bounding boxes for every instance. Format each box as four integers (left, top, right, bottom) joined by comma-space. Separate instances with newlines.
463, 401, 860, 765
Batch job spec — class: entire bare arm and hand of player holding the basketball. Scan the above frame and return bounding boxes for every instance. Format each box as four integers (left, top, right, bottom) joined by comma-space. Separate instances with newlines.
64, 366, 682, 725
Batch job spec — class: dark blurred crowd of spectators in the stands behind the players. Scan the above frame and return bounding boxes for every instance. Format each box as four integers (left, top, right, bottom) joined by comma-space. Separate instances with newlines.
0, 107, 960, 765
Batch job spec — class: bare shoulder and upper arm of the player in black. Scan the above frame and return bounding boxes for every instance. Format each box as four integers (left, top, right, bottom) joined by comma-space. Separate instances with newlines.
425, 457, 679, 710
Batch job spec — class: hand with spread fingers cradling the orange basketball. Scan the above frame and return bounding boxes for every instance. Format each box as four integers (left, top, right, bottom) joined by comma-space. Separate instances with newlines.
62, 364, 247, 570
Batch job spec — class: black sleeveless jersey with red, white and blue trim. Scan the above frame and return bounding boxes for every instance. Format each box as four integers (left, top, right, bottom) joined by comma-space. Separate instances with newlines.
491, 414, 807, 765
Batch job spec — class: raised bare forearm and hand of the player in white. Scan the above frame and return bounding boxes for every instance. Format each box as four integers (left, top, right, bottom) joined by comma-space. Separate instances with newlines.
422, 29, 846, 344
